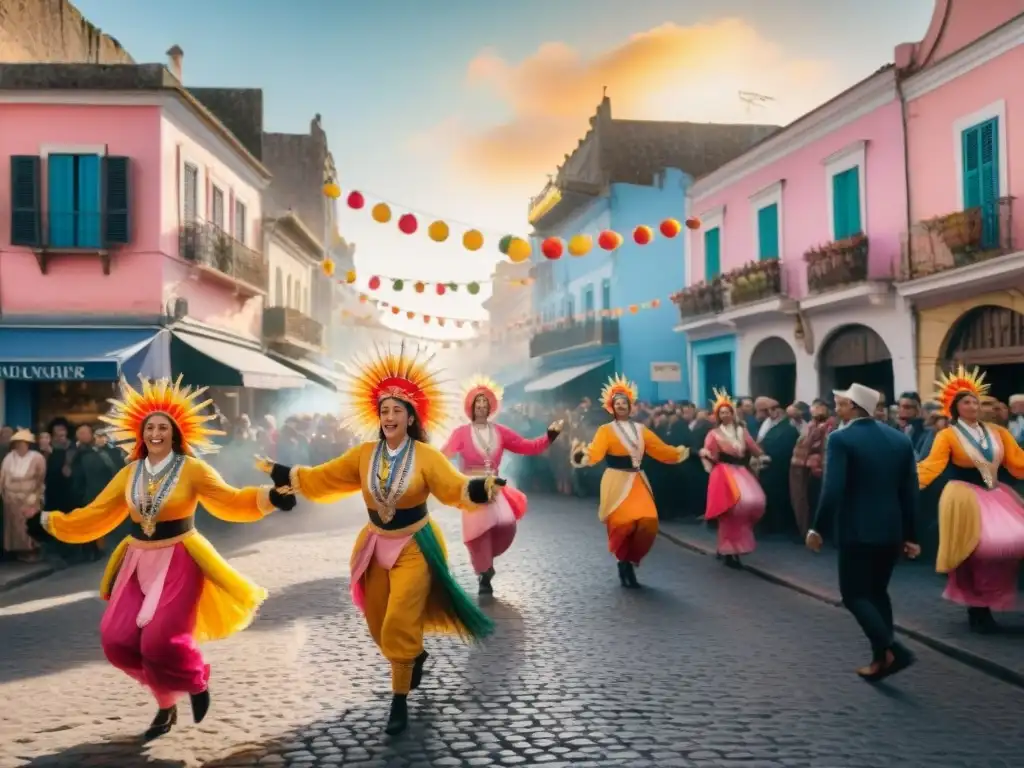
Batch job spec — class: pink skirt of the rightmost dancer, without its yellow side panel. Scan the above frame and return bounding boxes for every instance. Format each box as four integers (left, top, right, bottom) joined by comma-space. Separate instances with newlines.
942, 480, 1024, 610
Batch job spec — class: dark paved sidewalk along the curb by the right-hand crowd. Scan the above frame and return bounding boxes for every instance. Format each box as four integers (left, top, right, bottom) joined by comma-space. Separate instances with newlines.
662, 520, 1024, 687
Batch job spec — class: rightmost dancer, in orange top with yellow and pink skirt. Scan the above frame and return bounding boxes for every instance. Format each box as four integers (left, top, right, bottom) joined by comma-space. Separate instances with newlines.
918, 366, 1024, 633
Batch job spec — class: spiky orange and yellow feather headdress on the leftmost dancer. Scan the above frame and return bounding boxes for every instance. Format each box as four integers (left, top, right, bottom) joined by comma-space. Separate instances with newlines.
99, 376, 224, 461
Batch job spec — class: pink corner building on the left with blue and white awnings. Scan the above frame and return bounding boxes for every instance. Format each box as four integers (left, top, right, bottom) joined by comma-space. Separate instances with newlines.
0, 65, 304, 426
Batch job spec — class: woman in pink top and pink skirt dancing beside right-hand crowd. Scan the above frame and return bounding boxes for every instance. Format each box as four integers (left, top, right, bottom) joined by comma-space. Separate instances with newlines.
700, 389, 768, 568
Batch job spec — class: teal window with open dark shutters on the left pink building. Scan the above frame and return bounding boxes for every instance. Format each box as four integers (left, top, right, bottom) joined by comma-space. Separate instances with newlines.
10, 153, 131, 249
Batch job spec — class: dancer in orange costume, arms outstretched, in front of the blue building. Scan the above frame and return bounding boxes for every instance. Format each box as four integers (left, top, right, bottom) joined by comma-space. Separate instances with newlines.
569, 376, 690, 589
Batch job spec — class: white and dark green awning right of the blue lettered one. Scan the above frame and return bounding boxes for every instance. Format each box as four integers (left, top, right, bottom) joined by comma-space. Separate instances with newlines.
170, 328, 308, 389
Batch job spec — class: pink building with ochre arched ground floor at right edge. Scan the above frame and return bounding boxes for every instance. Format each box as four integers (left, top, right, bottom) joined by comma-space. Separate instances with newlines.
896, 0, 1024, 401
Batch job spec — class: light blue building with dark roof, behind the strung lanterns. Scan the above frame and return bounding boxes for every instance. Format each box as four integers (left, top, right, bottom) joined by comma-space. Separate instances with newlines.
524, 97, 774, 404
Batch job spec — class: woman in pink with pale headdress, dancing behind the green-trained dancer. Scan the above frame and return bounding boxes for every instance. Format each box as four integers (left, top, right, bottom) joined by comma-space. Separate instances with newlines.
441, 376, 562, 595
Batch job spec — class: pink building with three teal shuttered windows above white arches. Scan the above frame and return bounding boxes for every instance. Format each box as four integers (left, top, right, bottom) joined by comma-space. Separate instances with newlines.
677, 67, 914, 403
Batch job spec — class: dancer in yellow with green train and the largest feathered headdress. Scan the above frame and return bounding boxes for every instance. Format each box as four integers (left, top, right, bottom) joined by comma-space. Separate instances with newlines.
261, 344, 505, 734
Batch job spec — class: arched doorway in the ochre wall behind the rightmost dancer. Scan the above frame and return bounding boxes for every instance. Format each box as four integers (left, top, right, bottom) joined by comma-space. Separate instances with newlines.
940, 304, 1024, 402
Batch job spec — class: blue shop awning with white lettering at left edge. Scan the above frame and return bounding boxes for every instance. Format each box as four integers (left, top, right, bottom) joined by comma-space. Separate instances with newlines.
0, 326, 160, 381
